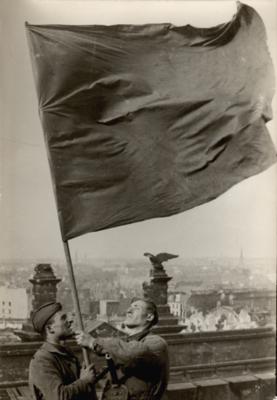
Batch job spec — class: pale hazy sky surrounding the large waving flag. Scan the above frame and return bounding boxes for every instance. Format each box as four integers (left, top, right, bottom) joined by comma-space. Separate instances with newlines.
0, 0, 277, 260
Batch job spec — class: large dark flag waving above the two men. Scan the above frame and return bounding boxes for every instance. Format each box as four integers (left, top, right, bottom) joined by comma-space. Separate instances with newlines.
27, 4, 276, 240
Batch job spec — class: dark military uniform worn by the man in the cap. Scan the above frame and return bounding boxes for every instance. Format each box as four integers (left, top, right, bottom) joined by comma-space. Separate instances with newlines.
29, 342, 96, 400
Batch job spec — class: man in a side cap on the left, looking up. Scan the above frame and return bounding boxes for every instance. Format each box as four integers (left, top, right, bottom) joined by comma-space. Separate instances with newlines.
29, 302, 96, 400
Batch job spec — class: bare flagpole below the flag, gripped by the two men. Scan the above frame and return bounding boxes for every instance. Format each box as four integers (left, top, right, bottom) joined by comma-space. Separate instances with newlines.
63, 241, 89, 366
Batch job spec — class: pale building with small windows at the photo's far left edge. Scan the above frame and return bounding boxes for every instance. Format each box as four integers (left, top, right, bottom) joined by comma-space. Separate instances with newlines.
0, 286, 28, 320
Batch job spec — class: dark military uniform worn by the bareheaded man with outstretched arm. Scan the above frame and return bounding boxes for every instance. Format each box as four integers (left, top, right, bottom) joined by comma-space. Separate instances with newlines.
94, 330, 169, 400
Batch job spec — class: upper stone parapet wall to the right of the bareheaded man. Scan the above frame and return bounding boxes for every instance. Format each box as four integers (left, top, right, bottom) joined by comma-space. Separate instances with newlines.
167, 328, 275, 377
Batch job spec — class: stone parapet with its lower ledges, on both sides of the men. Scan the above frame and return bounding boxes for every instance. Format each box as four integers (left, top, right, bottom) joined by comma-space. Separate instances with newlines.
0, 328, 275, 400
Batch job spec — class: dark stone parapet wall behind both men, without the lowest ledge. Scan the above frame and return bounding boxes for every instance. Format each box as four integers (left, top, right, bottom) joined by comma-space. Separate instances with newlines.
0, 328, 275, 384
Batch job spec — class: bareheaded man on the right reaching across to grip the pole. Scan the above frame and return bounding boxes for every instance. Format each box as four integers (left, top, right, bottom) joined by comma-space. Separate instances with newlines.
76, 299, 169, 400
